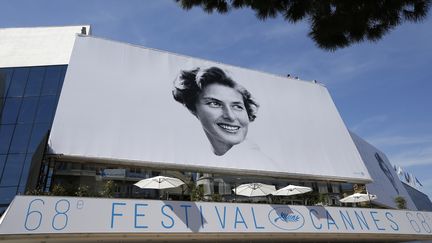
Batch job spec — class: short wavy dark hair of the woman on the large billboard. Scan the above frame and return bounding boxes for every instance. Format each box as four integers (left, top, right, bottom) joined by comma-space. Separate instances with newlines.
172, 67, 259, 121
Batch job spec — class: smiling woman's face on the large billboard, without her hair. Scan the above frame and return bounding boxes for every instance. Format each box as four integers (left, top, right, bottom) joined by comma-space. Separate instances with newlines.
196, 84, 249, 155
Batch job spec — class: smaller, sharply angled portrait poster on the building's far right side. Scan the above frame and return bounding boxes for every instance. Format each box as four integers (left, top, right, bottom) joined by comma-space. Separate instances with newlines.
351, 132, 417, 210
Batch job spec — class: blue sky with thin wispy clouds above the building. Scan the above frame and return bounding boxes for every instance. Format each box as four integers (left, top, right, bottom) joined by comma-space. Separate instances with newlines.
0, 0, 432, 198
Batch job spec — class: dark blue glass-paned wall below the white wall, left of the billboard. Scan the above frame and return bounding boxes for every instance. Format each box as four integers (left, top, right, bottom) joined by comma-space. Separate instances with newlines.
0, 65, 67, 212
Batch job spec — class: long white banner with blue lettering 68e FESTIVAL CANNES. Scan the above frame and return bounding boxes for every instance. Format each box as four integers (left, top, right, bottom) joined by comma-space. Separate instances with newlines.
0, 196, 432, 237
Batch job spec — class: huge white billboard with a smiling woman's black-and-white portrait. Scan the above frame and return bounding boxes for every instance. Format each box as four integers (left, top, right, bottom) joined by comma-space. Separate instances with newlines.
49, 37, 370, 182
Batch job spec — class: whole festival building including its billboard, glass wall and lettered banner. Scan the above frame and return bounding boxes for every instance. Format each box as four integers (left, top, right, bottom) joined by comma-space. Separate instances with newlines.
0, 26, 432, 241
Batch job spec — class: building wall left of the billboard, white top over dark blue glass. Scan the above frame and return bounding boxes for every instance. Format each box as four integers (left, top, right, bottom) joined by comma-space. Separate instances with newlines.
0, 26, 89, 211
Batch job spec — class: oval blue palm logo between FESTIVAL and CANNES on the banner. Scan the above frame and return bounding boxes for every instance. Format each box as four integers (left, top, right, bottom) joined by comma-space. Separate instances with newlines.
268, 207, 305, 230
